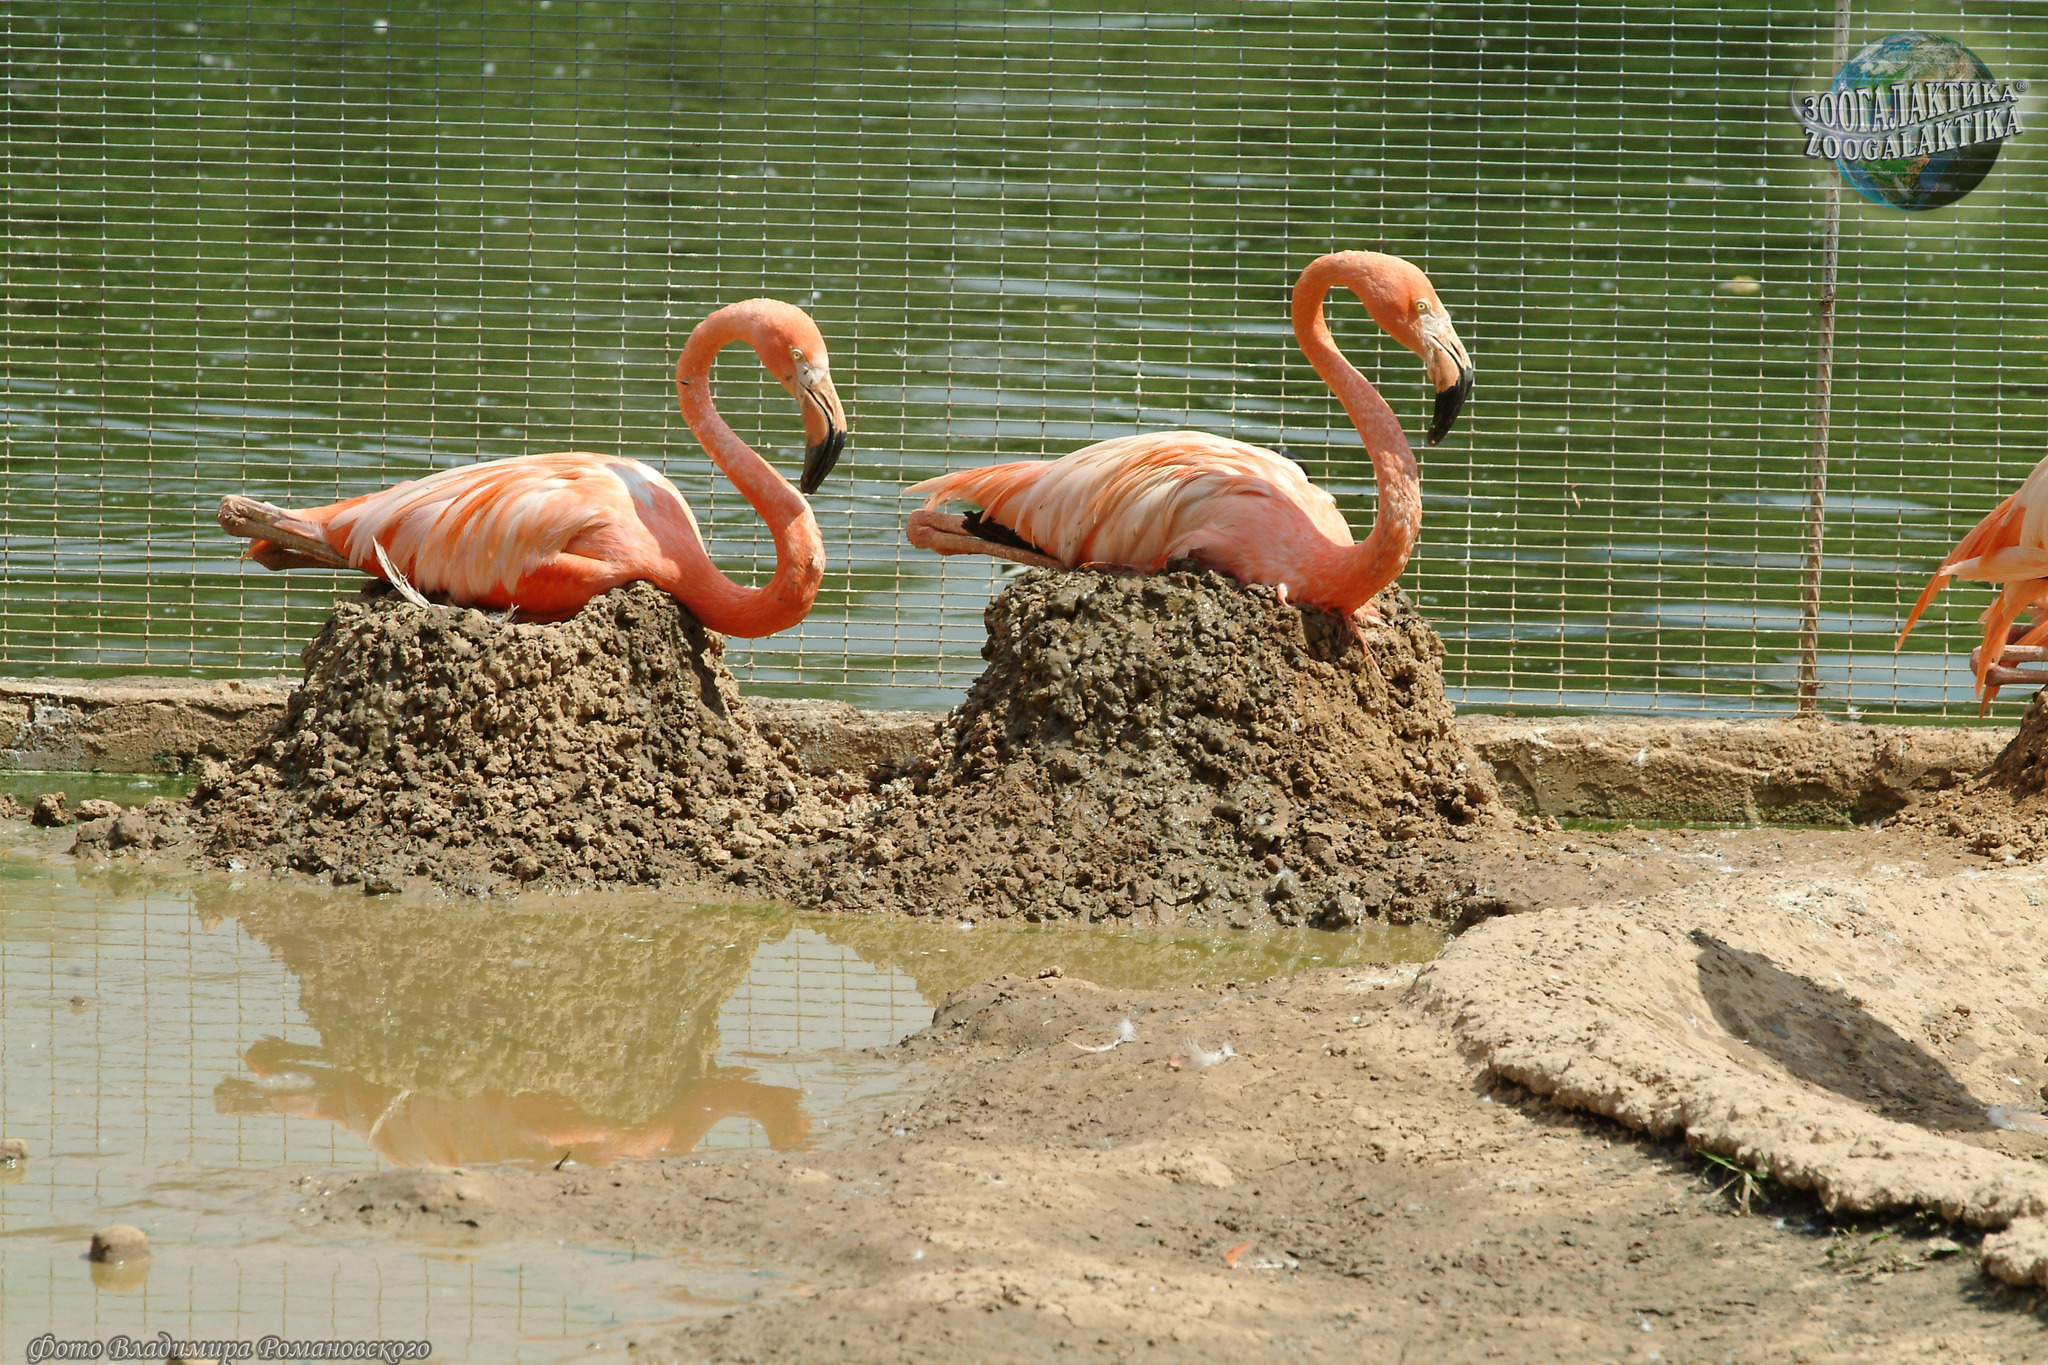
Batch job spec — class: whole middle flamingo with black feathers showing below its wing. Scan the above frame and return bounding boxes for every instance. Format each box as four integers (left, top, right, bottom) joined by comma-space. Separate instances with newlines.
905, 252, 1473, 630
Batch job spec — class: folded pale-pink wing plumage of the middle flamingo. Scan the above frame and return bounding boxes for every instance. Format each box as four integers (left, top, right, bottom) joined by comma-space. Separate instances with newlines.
909, 432, 1352, 577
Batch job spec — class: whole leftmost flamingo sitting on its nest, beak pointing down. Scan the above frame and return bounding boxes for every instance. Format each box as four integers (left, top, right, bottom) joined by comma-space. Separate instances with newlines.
219, 299, 846, 636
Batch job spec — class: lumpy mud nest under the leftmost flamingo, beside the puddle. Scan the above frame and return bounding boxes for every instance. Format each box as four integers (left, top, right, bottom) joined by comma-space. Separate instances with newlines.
193, 583, 823, 894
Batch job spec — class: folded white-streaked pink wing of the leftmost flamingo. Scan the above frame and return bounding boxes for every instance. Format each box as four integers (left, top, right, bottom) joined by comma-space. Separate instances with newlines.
321, 452, 696, 610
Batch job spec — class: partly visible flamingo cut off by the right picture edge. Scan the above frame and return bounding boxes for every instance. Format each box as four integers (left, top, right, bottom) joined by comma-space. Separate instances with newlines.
1892, 458, 2048, 712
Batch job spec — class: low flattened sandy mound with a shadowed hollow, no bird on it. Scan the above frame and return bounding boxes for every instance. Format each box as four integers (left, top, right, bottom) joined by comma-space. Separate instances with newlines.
1411, 868, 2048, 1283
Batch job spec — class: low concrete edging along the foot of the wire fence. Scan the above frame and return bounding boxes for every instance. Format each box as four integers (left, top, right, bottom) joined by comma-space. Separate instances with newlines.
0, 677, 2013, 823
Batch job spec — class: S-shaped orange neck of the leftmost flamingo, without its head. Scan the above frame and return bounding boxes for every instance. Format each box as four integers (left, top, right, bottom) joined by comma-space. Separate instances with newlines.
662, 303, 825, 636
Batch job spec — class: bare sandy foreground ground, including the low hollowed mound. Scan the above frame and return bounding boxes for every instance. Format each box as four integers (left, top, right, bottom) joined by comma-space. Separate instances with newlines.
284, 829, 2048, 1361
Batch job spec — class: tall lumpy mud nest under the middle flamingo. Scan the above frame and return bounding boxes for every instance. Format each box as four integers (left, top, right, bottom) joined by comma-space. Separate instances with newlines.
754, 565, 1503, 925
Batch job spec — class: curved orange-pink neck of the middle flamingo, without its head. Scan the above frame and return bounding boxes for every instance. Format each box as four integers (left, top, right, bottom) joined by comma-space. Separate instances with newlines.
1294, 256, 1421, 612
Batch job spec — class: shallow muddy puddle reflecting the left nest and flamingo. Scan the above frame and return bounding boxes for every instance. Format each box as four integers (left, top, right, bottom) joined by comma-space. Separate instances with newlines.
0, 774, 1440, 1361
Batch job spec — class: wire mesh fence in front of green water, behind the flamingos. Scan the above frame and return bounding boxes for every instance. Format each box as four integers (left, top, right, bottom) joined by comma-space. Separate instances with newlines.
0, 0, 2048, 714
